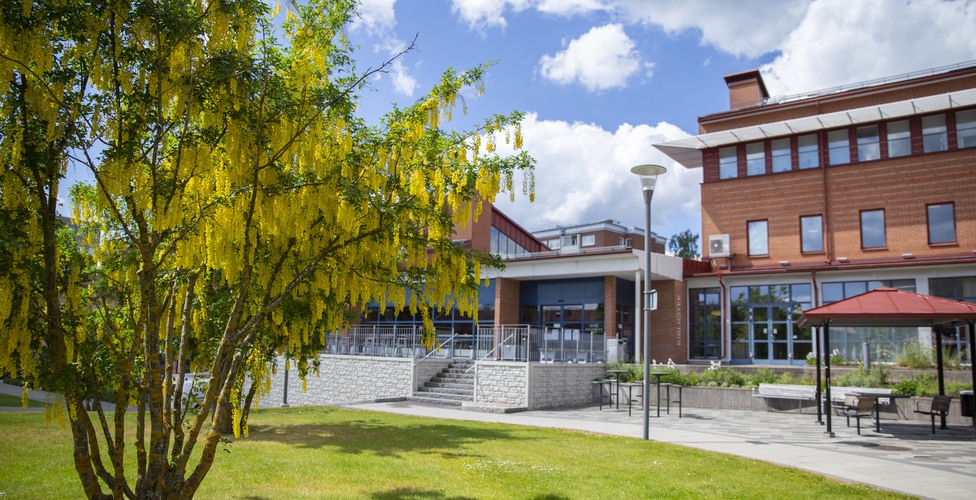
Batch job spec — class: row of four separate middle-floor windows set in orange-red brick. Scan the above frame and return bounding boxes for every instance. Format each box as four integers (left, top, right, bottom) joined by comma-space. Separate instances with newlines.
746, 202, 956, 257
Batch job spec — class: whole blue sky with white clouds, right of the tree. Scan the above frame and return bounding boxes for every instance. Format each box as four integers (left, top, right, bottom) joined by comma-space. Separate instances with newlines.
350, 0, 976, 246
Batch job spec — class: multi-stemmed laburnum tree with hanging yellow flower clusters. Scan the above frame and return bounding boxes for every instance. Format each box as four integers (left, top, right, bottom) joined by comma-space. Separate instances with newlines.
0, 0, 532, 498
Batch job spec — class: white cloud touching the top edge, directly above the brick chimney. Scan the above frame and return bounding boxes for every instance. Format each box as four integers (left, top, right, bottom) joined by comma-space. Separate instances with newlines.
613, 0, 808, 57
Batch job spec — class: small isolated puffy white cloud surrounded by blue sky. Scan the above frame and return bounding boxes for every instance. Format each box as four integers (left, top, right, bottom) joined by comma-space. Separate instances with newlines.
539, 24, 652, 92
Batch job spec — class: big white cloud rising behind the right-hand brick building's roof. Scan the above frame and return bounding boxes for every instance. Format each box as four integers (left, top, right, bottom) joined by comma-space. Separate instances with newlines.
761, 0, 976, 95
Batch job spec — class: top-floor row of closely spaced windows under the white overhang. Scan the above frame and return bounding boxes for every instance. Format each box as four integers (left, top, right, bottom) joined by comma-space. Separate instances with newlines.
718, 109, 976, 179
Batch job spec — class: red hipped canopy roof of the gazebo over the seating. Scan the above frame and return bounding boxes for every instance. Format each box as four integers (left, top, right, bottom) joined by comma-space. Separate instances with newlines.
799, 287, 976, 326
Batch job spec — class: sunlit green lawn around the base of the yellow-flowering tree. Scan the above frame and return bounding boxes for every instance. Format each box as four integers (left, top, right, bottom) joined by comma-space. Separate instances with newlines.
0, 408, 903, 499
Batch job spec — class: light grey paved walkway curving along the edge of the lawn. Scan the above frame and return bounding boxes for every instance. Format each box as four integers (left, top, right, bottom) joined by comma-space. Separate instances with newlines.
350, 401, 976, 500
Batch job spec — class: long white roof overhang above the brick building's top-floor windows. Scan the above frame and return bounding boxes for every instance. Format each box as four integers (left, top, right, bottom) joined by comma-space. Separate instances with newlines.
654, 89, 976, 168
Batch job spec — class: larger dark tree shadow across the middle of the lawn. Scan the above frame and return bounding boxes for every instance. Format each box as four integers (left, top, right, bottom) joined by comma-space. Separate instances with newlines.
247, 408, 531, 458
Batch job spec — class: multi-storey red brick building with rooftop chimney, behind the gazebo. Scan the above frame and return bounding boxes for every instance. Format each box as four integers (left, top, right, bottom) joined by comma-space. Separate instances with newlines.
656, 63, 976, 364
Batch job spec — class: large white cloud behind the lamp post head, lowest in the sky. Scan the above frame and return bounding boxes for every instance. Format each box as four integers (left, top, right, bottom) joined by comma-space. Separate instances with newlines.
495, 114, 702, 236
